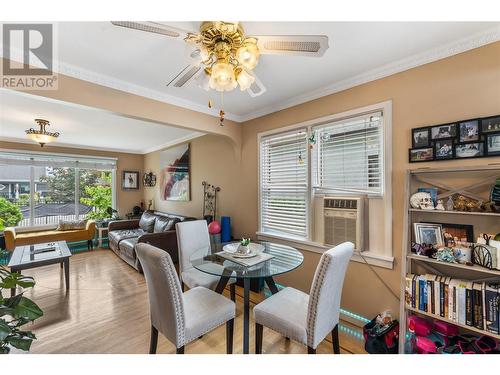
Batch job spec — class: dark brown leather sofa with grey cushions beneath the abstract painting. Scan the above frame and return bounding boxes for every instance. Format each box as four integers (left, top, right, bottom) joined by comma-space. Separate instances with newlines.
108, 211, 195, 272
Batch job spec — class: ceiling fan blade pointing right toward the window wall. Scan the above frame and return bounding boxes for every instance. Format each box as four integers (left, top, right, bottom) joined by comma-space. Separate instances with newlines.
255, 35, 328, 57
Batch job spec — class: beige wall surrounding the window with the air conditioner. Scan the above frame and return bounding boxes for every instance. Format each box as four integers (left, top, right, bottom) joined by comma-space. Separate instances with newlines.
235, 42, 500, 317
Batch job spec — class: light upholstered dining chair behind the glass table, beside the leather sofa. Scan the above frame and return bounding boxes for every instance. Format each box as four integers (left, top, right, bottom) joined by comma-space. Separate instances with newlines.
175, 220, 236, 301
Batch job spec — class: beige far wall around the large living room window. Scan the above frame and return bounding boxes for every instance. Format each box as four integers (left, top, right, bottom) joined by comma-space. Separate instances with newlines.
0, 141, 144, 216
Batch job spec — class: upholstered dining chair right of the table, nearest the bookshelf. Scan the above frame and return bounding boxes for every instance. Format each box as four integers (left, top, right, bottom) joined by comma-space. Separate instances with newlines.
253, 242, 354, 354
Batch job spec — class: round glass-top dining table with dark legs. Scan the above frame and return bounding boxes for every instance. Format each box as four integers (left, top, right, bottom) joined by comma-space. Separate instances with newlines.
190, 242, 304, 354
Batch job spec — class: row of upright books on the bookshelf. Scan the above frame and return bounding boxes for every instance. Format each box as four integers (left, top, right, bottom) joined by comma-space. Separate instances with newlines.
405, 274, 500, 334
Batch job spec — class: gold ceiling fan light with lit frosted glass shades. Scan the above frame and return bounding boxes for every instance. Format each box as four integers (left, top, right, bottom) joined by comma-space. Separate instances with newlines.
185, 21, 260, 92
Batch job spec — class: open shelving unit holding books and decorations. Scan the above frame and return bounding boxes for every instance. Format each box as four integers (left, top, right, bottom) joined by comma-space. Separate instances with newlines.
399, 163, 500, 353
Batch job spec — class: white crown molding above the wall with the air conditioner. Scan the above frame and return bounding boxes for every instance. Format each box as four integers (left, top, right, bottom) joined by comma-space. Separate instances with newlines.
236, 26, 500, 122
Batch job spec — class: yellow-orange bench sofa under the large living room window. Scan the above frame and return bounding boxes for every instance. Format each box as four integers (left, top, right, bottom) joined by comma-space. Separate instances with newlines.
4, 220, 95, 251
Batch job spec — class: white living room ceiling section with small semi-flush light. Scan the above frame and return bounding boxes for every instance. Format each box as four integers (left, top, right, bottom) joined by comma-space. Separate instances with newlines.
0, 89, 203, 154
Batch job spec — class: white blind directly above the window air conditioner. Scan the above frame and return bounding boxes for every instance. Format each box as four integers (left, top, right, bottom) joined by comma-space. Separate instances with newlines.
313, 112, 384, 195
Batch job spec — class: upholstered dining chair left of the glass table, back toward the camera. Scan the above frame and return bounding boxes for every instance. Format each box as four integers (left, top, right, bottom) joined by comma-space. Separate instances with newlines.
137, 243, 236, 354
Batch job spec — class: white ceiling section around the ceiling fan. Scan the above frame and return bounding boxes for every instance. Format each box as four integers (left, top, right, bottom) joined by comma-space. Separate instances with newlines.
42, 22, 500, 121
